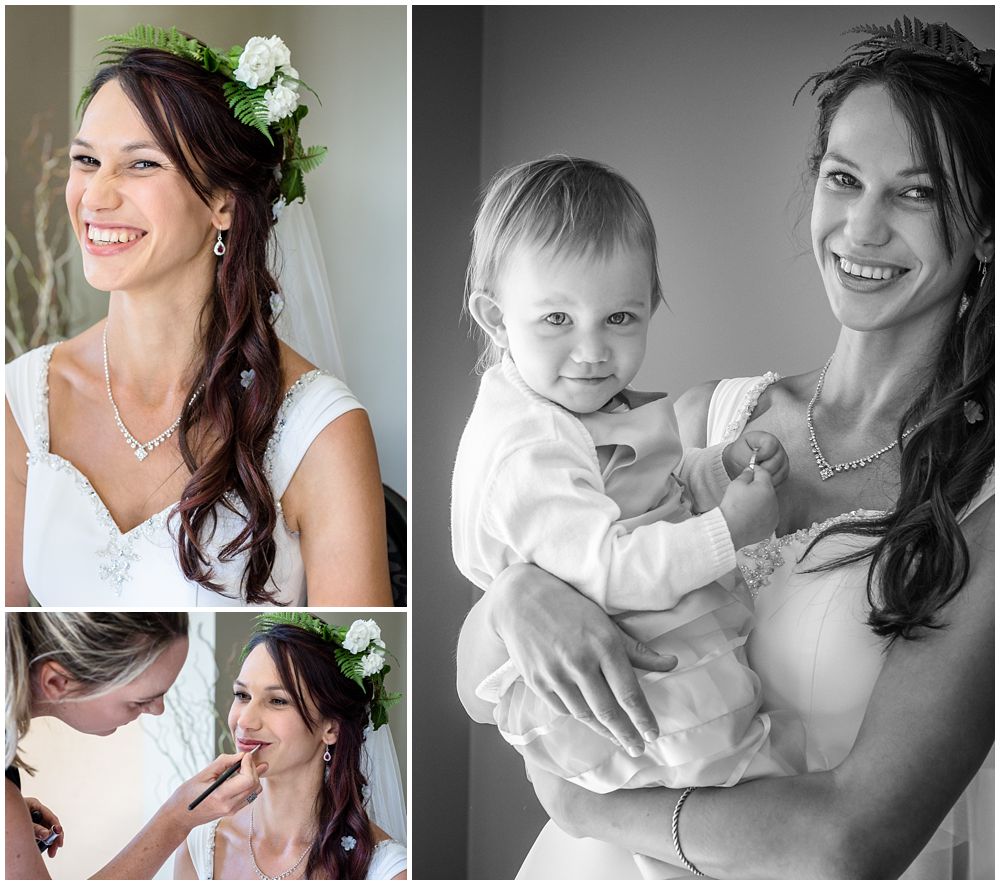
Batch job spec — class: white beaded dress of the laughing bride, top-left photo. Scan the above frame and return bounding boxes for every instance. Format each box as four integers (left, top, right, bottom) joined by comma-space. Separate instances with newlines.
6, 344, 362, 610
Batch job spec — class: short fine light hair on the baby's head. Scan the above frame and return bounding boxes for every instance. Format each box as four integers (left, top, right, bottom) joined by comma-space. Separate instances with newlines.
465, 155, 663, 370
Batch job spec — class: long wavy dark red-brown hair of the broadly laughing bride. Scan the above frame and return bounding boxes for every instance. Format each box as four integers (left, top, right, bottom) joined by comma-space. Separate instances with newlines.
82, 49, 282, 603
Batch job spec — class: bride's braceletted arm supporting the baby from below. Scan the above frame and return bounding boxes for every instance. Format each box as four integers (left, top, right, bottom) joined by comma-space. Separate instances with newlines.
536, 500, 994, 879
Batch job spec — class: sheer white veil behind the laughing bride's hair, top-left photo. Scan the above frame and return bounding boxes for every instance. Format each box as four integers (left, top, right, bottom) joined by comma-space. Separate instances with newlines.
269, 200, 347, 382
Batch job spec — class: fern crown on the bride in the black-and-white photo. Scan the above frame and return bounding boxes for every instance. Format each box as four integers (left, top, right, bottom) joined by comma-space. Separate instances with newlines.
793, 16, 993, 101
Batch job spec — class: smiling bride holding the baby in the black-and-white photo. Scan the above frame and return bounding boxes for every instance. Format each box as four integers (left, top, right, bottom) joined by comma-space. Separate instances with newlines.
458, 21, 996, 879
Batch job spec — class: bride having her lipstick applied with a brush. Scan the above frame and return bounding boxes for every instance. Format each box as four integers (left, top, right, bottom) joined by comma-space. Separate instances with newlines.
174, 612, 406, 879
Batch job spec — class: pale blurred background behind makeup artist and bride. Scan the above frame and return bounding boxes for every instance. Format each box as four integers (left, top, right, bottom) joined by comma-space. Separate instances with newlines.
21, 611, 410, 880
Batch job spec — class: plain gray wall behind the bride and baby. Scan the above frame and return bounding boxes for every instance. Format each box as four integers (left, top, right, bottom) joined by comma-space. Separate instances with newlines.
413, 6, 994, 878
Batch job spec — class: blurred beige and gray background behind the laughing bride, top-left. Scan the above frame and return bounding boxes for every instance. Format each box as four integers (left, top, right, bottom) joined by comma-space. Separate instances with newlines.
4, 4, 407, 495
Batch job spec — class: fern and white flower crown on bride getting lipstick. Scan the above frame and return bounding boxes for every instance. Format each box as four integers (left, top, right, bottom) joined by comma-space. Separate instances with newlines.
240, 612, 403, 730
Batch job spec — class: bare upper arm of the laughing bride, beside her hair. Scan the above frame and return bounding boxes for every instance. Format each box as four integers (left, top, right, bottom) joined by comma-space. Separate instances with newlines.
282, 409, 392, 606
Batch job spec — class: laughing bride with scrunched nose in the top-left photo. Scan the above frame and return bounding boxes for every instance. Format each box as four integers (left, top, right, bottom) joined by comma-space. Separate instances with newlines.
6, 28, 392, 608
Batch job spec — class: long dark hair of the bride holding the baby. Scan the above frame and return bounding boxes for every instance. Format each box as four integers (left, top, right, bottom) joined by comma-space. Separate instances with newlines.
806, 51, 995, 640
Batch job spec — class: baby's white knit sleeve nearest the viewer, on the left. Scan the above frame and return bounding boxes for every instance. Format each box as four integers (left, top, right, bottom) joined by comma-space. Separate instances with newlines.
483, 440, 736, 614
